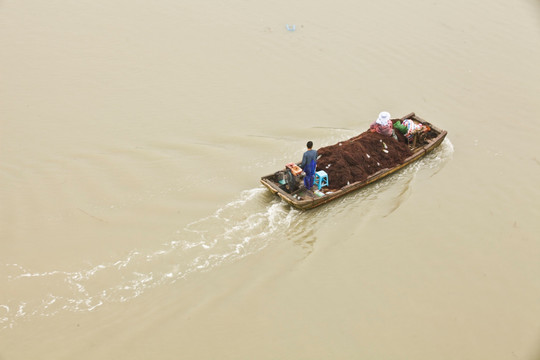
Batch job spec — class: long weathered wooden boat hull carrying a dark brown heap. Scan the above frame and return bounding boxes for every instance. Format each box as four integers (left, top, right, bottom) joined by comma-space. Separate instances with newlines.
260, 113, 447, 210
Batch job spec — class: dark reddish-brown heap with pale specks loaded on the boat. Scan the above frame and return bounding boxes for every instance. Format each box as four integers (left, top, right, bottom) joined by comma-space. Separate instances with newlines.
317, 130, 412, 189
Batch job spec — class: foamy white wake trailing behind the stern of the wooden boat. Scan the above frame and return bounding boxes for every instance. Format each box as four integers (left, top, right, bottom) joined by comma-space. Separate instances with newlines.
0, 188, 300, 329
